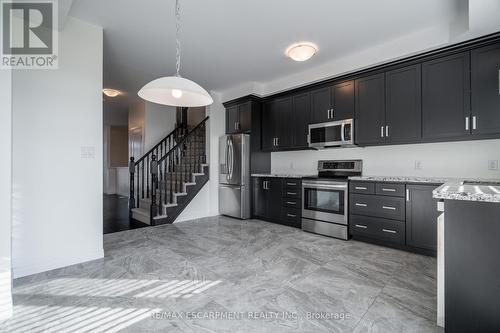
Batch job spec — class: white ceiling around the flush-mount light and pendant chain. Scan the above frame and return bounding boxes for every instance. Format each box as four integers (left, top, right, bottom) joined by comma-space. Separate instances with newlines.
70, 0, 462, 105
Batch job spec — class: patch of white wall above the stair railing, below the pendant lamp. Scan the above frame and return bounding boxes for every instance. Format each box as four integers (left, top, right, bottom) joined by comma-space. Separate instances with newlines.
144, 102, 176, 152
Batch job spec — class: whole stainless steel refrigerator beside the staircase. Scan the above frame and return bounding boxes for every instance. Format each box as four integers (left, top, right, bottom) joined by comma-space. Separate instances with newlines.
219, 134, 251, 219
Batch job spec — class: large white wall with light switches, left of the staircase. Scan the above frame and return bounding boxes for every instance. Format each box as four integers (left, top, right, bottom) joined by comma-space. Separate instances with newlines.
12, 18, 103, 277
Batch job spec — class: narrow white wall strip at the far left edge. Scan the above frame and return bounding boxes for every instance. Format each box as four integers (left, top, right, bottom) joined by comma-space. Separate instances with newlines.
0, 70, 12, 321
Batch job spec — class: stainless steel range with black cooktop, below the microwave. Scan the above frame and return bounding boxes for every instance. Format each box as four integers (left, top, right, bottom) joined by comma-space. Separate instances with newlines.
302, 160, 363, 240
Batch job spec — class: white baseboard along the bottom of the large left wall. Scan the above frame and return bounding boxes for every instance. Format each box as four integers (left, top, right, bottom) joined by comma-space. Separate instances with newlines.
12, 249, 104, 279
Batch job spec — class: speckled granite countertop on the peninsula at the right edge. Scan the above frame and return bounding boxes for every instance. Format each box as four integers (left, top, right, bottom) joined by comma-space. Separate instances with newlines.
432, 180, 500, 203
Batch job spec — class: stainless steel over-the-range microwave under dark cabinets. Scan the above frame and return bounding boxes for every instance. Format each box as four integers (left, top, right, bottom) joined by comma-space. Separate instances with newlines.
308, 119, 354, 149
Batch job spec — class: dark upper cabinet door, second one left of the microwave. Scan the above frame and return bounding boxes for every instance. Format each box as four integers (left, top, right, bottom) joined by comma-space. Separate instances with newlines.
273, 96, 293, 149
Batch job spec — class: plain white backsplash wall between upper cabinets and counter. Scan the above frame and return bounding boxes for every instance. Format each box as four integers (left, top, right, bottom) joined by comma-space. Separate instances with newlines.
271, 140, 500, 179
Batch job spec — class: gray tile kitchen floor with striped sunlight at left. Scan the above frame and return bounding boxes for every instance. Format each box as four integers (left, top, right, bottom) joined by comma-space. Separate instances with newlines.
0, 217, 441, 333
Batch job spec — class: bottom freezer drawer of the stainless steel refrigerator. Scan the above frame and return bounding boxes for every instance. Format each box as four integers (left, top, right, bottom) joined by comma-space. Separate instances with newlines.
219, 185, 250, 219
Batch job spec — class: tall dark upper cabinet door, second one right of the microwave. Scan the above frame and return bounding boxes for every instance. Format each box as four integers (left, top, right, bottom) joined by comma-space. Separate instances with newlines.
385, 64, 422, 143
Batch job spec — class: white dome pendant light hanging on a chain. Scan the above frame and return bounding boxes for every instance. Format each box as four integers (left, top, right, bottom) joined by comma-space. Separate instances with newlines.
138, 0, 214, 107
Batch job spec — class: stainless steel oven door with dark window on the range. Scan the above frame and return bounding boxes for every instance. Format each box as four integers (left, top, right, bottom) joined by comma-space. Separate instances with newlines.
302, 181, 348, 225
